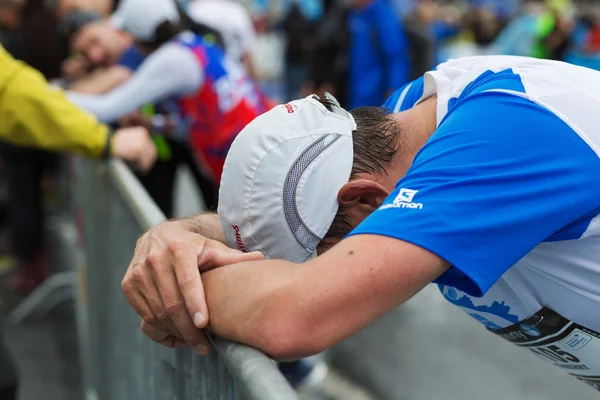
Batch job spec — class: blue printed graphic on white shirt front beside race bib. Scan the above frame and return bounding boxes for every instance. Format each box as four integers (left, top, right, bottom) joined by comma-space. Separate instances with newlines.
438, 285, 519, 330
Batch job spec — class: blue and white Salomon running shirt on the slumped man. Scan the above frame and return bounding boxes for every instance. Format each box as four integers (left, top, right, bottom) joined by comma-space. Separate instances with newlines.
351, 56, 600, 384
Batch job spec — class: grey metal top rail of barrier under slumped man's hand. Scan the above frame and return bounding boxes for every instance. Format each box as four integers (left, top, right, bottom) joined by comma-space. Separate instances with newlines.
108, 160, 298, 400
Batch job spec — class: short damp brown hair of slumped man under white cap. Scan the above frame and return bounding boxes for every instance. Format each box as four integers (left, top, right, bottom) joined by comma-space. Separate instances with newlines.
317, 99, 399, 254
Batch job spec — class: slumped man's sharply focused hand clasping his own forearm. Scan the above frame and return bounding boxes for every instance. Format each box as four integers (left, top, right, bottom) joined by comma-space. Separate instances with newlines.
122, 215, 263, 354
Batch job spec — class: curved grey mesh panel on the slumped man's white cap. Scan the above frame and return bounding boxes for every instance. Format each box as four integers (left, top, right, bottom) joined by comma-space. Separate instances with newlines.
283, 133, 341, 253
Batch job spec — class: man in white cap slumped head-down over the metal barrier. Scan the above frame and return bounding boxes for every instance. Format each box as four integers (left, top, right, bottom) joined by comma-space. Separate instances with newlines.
122, 56, 600, 388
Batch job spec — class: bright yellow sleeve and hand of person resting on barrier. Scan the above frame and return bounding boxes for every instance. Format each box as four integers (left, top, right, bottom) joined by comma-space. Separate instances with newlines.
0, 46, 156, 172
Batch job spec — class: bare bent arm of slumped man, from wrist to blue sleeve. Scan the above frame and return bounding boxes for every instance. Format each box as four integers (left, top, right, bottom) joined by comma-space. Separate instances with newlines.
202, 235, 449, 360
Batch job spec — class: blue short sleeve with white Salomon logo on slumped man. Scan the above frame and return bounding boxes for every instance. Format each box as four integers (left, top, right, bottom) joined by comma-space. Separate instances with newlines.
351, 92, 600, 296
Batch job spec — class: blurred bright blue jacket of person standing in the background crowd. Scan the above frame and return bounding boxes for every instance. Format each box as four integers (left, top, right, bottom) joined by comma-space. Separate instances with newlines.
348, 0, 409, 108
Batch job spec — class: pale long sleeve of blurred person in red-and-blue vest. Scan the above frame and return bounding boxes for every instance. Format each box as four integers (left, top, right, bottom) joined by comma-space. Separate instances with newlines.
68, 43, 204, 122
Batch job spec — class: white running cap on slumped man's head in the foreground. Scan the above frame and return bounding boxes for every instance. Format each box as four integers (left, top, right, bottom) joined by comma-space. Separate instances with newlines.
218, 95, 356, 262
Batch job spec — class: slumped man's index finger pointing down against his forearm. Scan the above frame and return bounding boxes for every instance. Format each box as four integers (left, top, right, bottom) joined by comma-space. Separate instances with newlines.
171, 239, 209, 328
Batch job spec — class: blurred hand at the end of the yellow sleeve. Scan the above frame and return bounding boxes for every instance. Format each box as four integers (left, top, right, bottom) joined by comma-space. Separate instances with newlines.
112, 127, 157, 172
